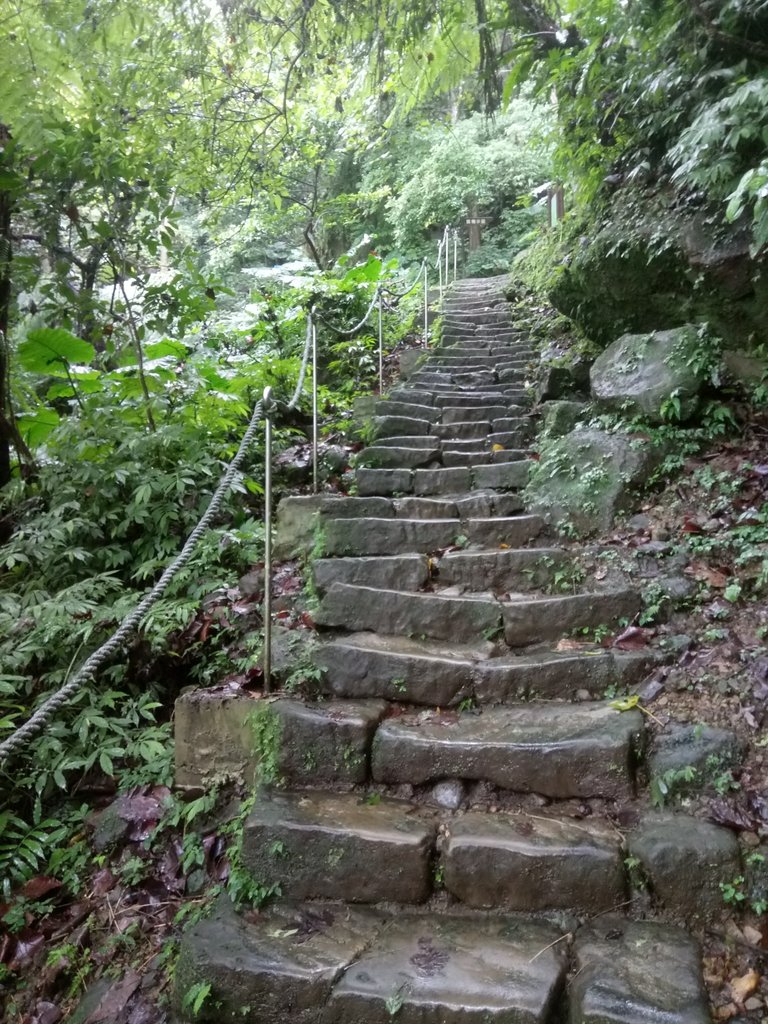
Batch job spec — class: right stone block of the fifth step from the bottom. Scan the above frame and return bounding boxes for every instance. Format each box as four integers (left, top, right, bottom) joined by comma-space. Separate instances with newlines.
505, 589, 641, 647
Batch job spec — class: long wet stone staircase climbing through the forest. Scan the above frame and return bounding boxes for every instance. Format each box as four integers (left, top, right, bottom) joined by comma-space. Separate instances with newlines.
177, 279, 720, 1024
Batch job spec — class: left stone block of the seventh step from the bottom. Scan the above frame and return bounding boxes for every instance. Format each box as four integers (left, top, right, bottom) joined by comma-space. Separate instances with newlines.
322, 516, 463, 555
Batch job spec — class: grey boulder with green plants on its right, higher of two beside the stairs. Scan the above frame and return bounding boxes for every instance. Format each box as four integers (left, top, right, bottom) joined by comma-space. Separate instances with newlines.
590, 325, 702, 423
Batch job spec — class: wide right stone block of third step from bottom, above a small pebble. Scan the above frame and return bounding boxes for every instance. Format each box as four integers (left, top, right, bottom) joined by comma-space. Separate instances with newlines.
371, 703, 643, 800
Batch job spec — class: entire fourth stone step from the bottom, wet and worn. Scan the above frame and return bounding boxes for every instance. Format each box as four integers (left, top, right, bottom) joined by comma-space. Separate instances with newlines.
314, 633, 656, 708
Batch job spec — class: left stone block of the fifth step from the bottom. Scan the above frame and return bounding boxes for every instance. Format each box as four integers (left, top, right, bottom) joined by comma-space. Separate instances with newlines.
314, 583, 502, 643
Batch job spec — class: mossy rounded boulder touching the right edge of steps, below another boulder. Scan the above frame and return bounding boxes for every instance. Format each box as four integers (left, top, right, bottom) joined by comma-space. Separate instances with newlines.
525, 427, 656, 534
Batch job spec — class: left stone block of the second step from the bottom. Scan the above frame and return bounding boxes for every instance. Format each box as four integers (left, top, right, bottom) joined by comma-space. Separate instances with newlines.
242, 792, 436, 903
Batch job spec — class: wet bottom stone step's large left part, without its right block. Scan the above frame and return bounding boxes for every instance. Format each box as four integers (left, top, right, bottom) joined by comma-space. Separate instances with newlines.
174, 900, 573, 1024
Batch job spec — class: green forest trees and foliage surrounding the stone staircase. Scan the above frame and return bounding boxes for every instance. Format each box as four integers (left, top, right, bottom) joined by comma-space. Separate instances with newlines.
0, 0, 768, 1015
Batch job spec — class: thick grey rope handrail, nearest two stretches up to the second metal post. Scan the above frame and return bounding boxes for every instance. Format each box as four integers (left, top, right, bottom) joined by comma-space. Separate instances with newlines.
0, 316, 312, 765
